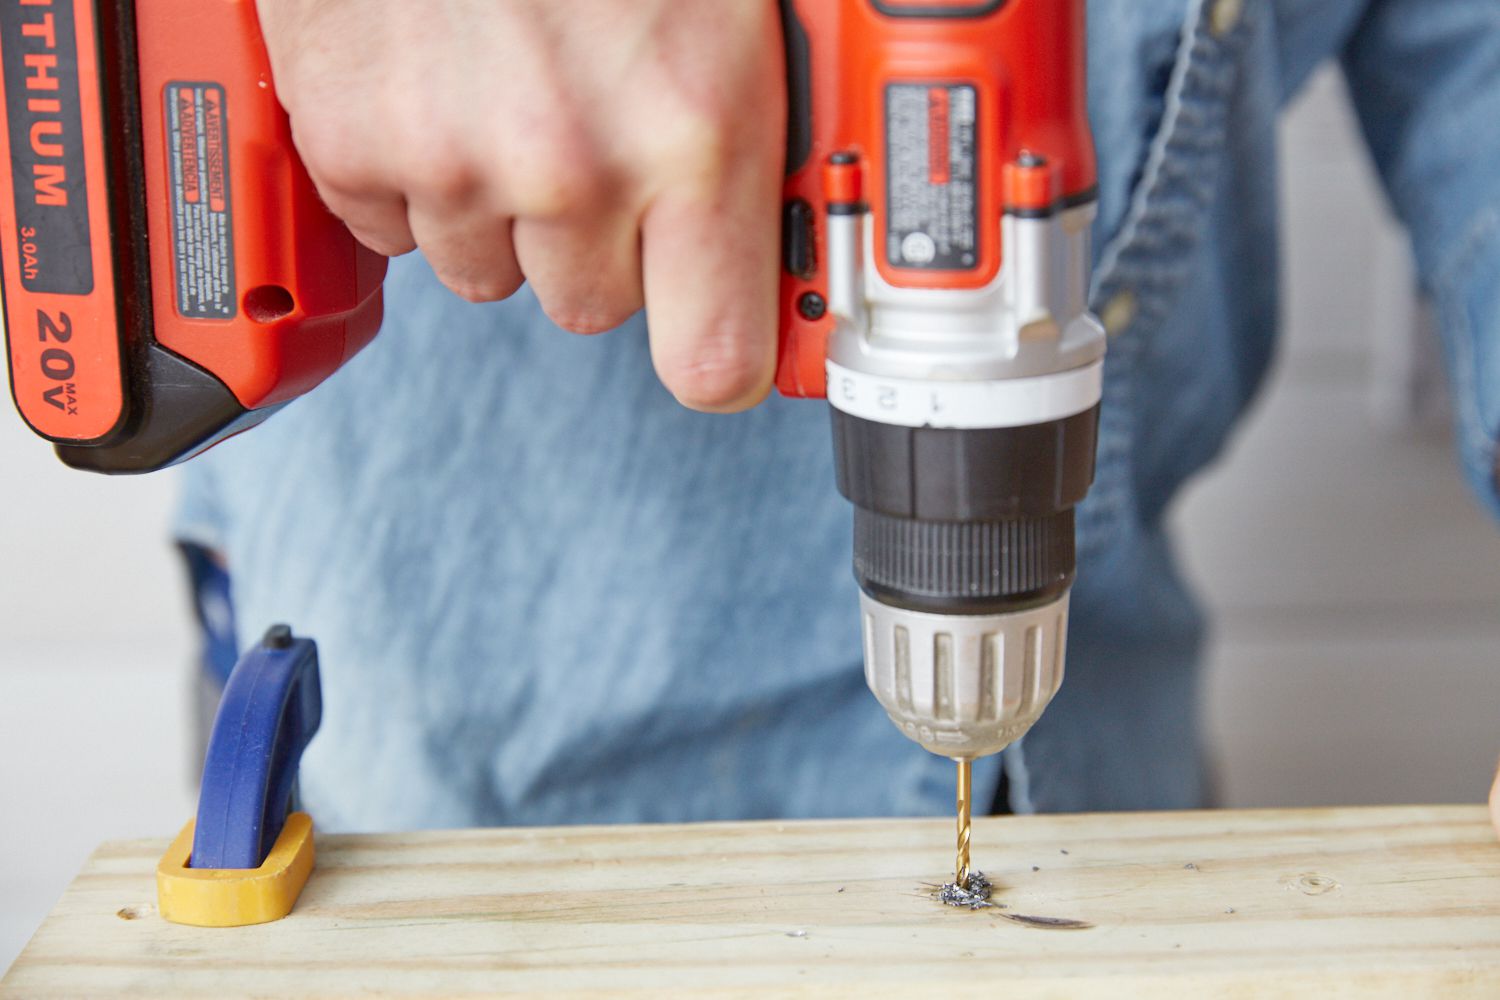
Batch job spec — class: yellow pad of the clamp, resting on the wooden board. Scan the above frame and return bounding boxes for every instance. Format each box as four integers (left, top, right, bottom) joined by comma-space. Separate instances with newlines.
156, 813, 314, 927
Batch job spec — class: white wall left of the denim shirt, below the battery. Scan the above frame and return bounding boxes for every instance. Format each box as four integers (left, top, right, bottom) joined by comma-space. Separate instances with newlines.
0, 416, 195, 969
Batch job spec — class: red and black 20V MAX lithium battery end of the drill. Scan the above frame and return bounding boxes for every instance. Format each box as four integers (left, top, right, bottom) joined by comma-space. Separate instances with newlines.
0, 0, 386, 472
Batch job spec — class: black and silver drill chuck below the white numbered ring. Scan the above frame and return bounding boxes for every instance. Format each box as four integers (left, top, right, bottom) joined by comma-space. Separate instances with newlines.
834, 405, 1098, 760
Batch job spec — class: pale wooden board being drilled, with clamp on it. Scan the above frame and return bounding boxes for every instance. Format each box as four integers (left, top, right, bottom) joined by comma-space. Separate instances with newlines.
0, 807, 1500, 1000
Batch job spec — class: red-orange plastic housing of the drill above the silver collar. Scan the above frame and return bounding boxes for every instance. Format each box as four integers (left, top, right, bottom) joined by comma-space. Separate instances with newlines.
777, 0, 1097, 396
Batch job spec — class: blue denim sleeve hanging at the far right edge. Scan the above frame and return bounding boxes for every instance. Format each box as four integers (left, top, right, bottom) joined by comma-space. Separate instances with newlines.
1344, 0, 1500, 517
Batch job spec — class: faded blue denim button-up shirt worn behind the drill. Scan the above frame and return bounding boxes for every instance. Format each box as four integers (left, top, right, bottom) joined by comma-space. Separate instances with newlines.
180, 0, 1500, 829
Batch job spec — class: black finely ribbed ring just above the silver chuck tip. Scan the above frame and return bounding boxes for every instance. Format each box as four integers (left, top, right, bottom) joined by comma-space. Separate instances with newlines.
854, 508, 1077, 615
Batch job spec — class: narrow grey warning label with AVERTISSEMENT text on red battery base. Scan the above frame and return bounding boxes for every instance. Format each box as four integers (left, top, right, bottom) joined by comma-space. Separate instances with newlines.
165, 82, 237, 319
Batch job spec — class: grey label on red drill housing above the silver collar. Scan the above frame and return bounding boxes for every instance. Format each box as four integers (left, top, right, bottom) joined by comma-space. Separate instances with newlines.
885, 84, 980, 271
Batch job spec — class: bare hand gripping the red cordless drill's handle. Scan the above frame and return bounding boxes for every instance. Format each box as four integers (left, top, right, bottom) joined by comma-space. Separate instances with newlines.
258, 0, 786, 411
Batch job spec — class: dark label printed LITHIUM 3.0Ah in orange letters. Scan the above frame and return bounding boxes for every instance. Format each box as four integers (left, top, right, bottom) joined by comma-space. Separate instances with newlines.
0, 0, 95, 295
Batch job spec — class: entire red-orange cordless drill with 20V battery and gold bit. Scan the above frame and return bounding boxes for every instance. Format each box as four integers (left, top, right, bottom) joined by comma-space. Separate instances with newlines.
0, 0, 1104, 885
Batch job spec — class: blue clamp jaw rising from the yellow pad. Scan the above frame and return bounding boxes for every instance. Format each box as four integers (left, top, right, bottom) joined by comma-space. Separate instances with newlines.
189, 625, 323, 868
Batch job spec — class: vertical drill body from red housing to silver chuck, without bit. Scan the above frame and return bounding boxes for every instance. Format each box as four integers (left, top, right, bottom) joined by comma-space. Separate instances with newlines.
780, 0, 1104, 760
